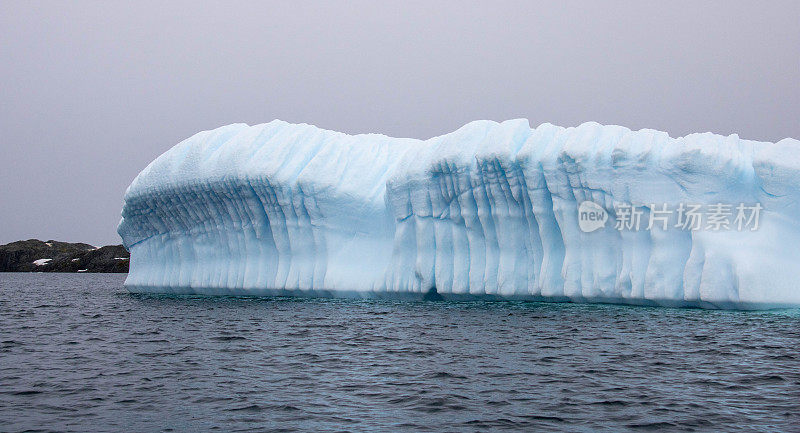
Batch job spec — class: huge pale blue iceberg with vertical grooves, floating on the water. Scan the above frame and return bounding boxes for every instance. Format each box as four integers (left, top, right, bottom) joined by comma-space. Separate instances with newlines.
118, 119, 800, 309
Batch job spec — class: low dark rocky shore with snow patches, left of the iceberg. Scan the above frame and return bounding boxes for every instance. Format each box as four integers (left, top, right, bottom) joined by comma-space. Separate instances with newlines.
0, 239, 130, 272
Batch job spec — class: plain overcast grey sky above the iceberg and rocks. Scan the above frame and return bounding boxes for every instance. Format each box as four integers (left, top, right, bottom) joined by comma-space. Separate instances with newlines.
0, 0, 800, 245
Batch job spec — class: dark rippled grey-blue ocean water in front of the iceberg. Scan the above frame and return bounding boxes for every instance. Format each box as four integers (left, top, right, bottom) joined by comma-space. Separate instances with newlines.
0, 273, 800, 432
